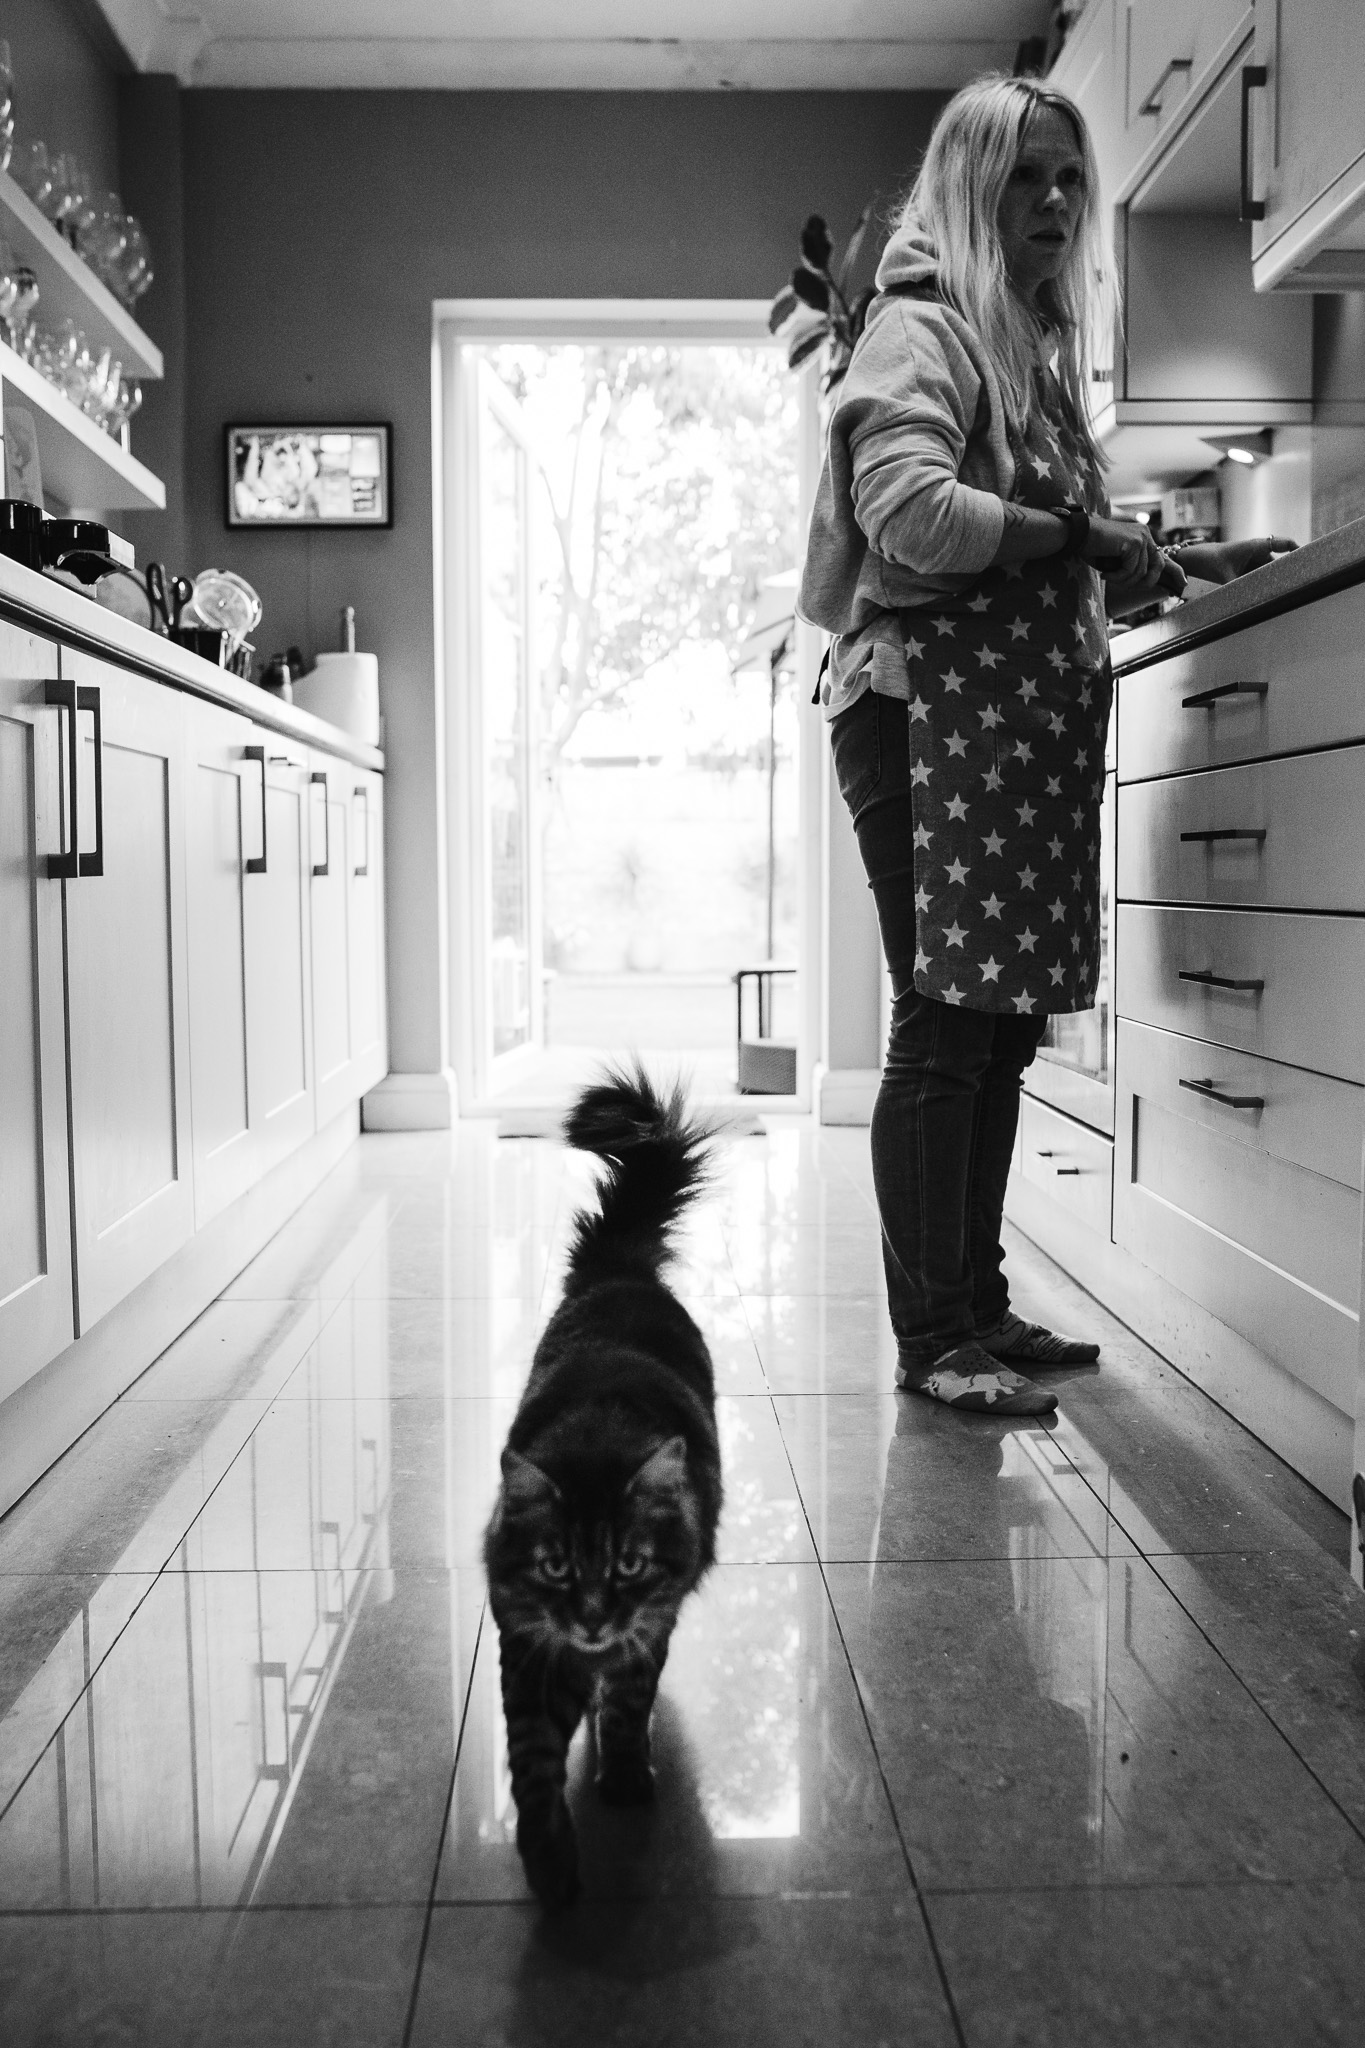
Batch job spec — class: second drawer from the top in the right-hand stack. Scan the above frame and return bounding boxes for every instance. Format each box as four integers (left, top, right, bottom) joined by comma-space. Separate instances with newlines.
1117, 748, 1365, 911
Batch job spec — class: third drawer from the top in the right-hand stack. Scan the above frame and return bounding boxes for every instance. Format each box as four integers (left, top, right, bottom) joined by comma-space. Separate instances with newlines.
1115, 903, 1365, 1083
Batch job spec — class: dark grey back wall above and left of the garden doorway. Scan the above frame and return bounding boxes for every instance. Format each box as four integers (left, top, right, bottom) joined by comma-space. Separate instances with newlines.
182, 92, 941, 1071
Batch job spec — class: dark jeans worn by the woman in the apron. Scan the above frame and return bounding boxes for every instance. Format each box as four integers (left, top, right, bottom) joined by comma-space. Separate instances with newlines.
829, 690, 1048, 1364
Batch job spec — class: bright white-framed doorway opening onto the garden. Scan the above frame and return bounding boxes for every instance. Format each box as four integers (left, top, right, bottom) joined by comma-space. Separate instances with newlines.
436, 301, 823, 1114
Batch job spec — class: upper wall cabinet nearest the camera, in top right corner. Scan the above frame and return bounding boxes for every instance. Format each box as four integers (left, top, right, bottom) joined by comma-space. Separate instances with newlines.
1248, 0, 1365, 291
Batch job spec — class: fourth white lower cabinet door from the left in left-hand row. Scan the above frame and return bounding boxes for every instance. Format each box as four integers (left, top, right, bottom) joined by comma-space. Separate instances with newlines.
244, 745, 313, 1174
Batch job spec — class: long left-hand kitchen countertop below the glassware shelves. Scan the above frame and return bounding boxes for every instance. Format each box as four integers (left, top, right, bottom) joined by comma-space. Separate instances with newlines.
0, 555, 385, 768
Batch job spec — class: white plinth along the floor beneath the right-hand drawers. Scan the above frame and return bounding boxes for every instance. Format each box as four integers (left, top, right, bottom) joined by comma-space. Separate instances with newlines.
1005, 1171, 1353, 1513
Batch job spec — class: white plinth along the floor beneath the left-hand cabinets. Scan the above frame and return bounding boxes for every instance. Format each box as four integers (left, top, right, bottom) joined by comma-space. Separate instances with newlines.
0, 1104, 360, 1513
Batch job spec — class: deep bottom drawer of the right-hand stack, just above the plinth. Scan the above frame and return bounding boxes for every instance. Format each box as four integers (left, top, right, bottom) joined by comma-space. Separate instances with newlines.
1113, 1020, 1365, 1411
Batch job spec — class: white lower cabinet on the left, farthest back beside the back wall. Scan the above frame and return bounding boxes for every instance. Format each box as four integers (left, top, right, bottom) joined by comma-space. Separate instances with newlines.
309, 754, 387, 1130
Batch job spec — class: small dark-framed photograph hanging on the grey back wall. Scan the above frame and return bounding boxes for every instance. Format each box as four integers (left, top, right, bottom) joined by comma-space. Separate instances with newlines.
223, 422, 393, 530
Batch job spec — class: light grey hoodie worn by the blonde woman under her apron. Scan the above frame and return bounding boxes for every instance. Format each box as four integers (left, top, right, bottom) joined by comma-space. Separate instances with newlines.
796, 225, 1015, 715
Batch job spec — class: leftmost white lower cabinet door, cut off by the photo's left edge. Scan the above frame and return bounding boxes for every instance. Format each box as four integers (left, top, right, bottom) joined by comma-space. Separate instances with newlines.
0, 621, 76, 1401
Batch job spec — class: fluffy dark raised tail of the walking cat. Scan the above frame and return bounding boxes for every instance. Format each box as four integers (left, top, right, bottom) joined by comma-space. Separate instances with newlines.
565, 1065, 714, 1294
